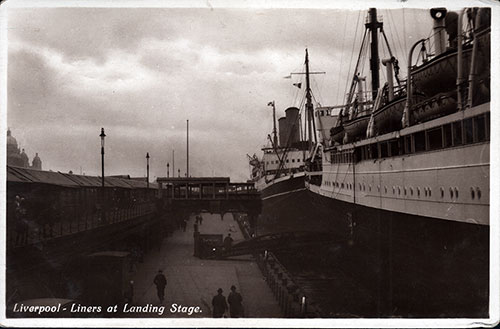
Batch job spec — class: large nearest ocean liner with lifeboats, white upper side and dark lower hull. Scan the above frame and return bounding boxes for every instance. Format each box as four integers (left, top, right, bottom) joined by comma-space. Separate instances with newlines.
252, 8, 491, 317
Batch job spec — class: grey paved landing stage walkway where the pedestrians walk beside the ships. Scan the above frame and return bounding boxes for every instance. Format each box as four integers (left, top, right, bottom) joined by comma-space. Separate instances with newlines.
129, 213, 282, 318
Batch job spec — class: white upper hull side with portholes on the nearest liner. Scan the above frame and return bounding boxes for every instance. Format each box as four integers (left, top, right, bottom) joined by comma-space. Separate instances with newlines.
308, 104, 490, 225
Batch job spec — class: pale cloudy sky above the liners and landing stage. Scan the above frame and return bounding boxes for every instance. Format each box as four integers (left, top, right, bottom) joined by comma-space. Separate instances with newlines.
7, 2, 431, 181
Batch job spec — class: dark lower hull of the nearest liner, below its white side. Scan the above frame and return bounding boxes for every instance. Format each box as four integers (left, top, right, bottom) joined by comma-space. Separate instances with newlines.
257, 184, 489, 318
